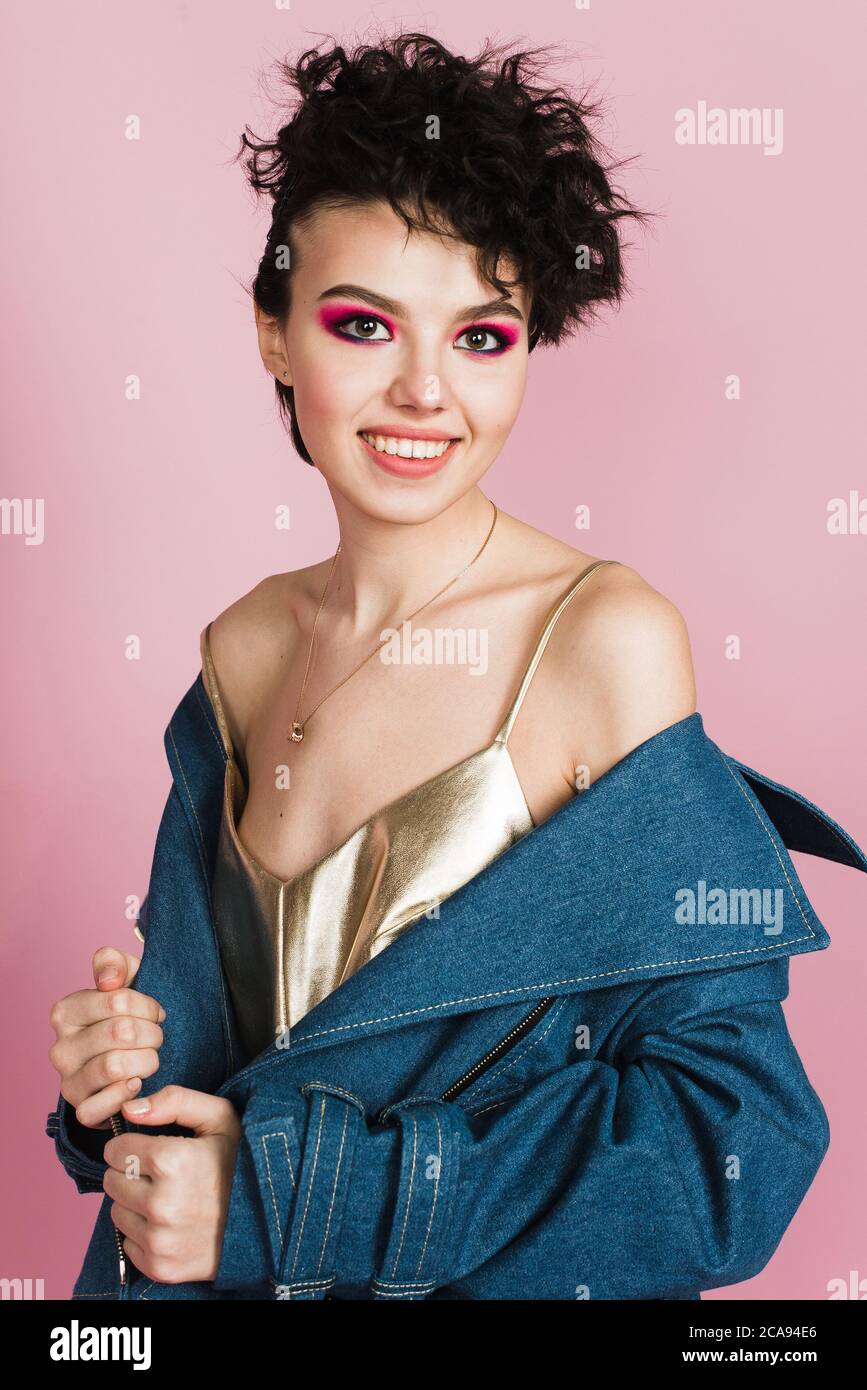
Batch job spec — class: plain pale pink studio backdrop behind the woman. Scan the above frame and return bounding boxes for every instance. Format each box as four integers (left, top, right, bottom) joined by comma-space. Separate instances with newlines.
0, 0, 867, 1300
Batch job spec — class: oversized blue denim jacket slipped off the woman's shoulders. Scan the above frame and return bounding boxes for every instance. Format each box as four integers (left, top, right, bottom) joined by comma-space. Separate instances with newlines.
46, 674, 867, 1300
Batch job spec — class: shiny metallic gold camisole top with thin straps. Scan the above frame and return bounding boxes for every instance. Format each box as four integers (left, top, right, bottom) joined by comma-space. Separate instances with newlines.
204, 560, 617, 1056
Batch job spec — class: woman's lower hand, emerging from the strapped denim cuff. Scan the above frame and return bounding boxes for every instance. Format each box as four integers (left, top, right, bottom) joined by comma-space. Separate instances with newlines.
103, 1086, 240, 1284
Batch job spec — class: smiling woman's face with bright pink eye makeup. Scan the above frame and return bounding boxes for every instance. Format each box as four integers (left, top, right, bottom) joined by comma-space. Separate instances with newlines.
257, 203, 529, 521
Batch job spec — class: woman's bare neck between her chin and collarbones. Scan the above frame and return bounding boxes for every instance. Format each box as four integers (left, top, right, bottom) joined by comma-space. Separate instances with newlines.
318, 487, 495, 641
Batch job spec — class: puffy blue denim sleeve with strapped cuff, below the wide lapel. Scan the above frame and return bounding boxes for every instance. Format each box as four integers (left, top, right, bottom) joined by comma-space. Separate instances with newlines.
215, 956, 829, 1300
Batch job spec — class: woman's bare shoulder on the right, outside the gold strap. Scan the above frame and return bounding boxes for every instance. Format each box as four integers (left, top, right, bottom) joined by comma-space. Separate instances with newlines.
554, 562, 696, 778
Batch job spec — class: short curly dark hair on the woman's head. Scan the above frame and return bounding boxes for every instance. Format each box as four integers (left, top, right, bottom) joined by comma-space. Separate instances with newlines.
235, 33, 653, 463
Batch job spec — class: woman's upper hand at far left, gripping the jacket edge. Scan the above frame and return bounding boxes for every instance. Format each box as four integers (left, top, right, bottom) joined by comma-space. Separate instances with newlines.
49, 947, 165, 1129
